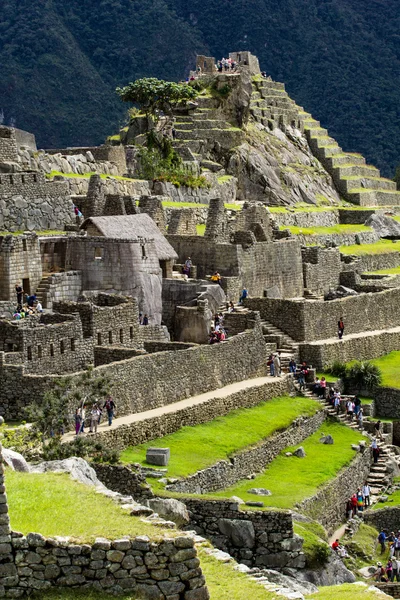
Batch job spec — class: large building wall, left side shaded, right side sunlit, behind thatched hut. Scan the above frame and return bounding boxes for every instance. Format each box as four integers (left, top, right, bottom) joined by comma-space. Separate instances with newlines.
167, 235, 304, 300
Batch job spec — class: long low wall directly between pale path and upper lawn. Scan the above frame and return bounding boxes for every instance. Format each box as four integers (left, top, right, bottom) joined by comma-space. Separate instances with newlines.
90, 376, 292, 450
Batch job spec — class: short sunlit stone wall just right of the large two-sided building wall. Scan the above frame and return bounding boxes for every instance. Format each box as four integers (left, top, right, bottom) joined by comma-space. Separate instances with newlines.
301, 246, 342, 296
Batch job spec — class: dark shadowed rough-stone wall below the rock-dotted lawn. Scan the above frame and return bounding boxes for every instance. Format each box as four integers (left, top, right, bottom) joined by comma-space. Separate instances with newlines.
183, 498, 305, 569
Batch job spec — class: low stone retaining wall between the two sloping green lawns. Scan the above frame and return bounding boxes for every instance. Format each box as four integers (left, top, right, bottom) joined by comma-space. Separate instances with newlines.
167, 410, 326, 494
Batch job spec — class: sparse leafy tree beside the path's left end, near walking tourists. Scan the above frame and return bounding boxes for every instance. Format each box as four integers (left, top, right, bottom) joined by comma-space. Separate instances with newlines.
27, 367, 110, 441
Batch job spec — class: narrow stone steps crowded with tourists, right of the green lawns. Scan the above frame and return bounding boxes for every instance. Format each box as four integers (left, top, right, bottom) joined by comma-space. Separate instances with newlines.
296, 385, 396, 501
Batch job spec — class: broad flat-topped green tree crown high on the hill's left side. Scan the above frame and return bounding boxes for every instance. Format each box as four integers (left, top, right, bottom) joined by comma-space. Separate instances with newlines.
116, 77, 197, 117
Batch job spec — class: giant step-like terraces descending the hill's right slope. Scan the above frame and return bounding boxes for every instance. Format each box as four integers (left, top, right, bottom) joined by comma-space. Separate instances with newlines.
299, 112, 400, 206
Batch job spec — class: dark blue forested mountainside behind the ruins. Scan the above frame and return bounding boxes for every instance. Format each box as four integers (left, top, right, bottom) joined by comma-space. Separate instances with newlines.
0, 0, 400, 175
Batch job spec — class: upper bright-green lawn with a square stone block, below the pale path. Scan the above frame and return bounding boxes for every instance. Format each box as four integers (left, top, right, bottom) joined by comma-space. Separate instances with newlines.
121, 396, 320, 477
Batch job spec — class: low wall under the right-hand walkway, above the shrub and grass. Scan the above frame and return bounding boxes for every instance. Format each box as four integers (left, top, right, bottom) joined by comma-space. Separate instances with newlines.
299, 327, 400, 369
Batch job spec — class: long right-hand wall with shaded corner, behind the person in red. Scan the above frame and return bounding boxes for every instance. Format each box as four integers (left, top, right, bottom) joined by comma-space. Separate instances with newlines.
245, 288, 400, 342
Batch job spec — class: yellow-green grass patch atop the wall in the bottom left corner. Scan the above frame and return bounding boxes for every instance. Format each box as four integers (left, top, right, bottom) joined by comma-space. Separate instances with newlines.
6, 470, 162, 542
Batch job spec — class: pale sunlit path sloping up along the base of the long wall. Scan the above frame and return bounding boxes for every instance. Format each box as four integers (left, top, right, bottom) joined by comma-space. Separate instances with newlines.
62, 376, 277, 442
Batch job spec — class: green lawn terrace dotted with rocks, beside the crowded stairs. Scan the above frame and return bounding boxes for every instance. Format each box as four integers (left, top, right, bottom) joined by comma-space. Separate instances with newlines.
208, 422, 366, 508
